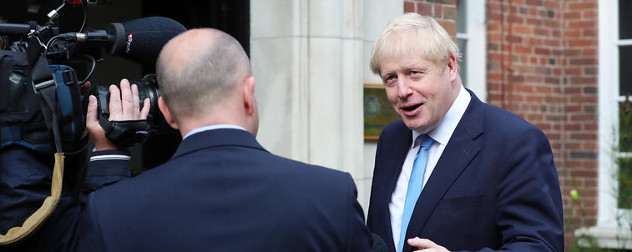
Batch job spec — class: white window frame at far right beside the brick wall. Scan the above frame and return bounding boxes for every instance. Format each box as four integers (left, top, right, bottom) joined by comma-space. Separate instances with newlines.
575, 0, 632, 249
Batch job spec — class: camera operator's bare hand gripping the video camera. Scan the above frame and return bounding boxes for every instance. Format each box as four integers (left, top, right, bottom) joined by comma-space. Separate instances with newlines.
86, 79, 150, 151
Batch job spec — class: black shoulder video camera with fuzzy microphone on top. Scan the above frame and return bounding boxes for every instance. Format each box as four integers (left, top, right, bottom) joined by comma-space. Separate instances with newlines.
0, 0, 186, 153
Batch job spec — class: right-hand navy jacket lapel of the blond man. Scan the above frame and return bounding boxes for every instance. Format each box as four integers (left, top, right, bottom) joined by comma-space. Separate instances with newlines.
404, 90, 484, 251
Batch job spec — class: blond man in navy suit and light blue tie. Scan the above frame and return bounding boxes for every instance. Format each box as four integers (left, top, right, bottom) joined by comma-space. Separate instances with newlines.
367, 13, 564, 252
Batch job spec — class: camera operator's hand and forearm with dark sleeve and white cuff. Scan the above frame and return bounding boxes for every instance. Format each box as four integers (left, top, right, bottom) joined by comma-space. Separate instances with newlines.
86, 79, 149, 191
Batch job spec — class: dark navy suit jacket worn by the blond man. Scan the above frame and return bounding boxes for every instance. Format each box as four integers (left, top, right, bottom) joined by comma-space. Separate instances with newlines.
367, 92, 564, 251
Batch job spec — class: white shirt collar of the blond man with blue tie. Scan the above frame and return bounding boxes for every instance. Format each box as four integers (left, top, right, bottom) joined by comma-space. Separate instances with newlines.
413, 85, 472, 147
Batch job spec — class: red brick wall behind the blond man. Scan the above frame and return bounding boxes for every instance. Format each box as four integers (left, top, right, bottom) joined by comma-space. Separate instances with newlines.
404, 0, 598, 250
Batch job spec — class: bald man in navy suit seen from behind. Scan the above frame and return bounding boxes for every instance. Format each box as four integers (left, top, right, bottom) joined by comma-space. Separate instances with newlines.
51, 29, 372, 251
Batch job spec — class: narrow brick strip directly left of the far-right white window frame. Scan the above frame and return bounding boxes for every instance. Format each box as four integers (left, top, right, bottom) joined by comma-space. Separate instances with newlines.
560, 0, 600, 244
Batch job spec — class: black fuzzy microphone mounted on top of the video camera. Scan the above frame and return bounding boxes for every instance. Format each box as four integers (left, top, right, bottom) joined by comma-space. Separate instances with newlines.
60, 17, 186, 64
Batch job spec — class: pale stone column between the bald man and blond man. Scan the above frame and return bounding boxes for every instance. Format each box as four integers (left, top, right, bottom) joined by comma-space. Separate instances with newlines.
250, 0, 403, 209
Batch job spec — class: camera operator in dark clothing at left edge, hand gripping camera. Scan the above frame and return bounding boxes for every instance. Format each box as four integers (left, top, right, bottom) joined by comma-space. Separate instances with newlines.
0, 79, 149, 251
